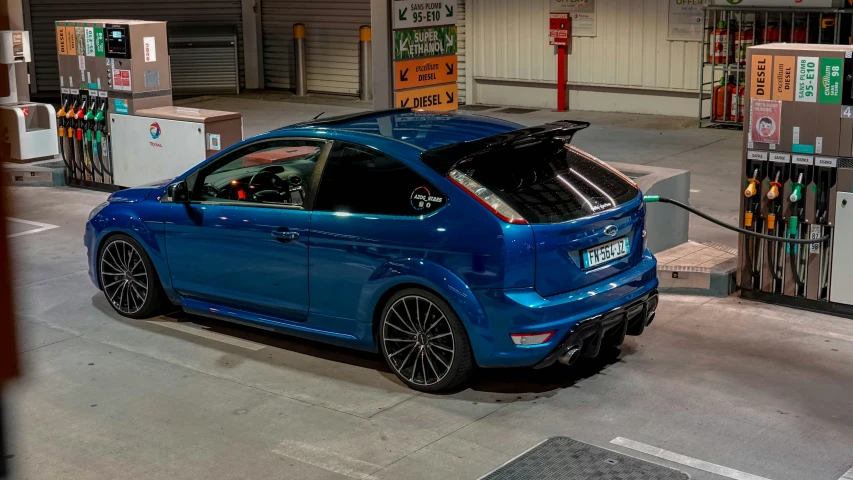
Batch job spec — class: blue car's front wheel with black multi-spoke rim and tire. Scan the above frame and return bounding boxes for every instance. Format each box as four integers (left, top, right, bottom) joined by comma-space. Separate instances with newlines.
98, 234, 168, 319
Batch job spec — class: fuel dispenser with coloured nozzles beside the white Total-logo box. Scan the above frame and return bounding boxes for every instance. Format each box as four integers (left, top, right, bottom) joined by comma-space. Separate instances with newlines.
55, 19, 172, 187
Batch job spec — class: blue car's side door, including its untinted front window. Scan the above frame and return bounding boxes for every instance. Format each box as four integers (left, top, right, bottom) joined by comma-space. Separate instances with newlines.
165, 139, 329, 321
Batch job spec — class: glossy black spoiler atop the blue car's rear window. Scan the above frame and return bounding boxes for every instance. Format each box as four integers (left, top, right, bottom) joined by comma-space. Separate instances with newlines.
421, 120, 589, 175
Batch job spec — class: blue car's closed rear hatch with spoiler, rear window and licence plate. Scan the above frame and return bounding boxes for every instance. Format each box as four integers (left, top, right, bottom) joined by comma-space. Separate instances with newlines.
421, 122, 645, 296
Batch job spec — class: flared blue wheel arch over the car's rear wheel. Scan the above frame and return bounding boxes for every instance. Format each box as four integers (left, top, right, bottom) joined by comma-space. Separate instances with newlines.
356, 258, 493, 364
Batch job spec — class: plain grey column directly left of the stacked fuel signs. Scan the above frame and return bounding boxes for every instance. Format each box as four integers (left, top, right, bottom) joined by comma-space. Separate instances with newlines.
370, 0, 393, 110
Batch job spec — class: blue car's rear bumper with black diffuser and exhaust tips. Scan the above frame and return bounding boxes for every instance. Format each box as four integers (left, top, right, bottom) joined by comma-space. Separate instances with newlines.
466, 251, 658, 368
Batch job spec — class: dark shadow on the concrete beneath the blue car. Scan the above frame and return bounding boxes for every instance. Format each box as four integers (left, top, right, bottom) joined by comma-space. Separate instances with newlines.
92, 294, 636, 403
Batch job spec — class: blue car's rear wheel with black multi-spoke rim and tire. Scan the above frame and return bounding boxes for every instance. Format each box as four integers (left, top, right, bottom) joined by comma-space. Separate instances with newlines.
378, 288, 474, 392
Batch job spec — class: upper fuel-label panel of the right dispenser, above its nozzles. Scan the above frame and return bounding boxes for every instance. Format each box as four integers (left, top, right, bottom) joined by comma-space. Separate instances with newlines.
744, 43, 853, 157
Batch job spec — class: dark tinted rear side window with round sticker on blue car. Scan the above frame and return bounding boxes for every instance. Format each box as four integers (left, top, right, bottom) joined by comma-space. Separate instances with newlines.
314, 143, 447, 216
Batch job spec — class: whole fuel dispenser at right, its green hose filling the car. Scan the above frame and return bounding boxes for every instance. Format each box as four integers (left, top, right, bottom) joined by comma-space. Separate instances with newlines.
738, 44, 853, 316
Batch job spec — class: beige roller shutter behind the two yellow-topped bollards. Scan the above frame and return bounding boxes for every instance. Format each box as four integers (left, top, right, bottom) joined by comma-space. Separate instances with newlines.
261, 0, 370, 95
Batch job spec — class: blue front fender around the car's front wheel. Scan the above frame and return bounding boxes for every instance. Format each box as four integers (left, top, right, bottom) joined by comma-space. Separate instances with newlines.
84, 203, 173, 298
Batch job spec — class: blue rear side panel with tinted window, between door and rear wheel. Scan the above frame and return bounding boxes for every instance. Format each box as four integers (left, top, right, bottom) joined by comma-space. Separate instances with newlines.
309, 142, 447, 336
